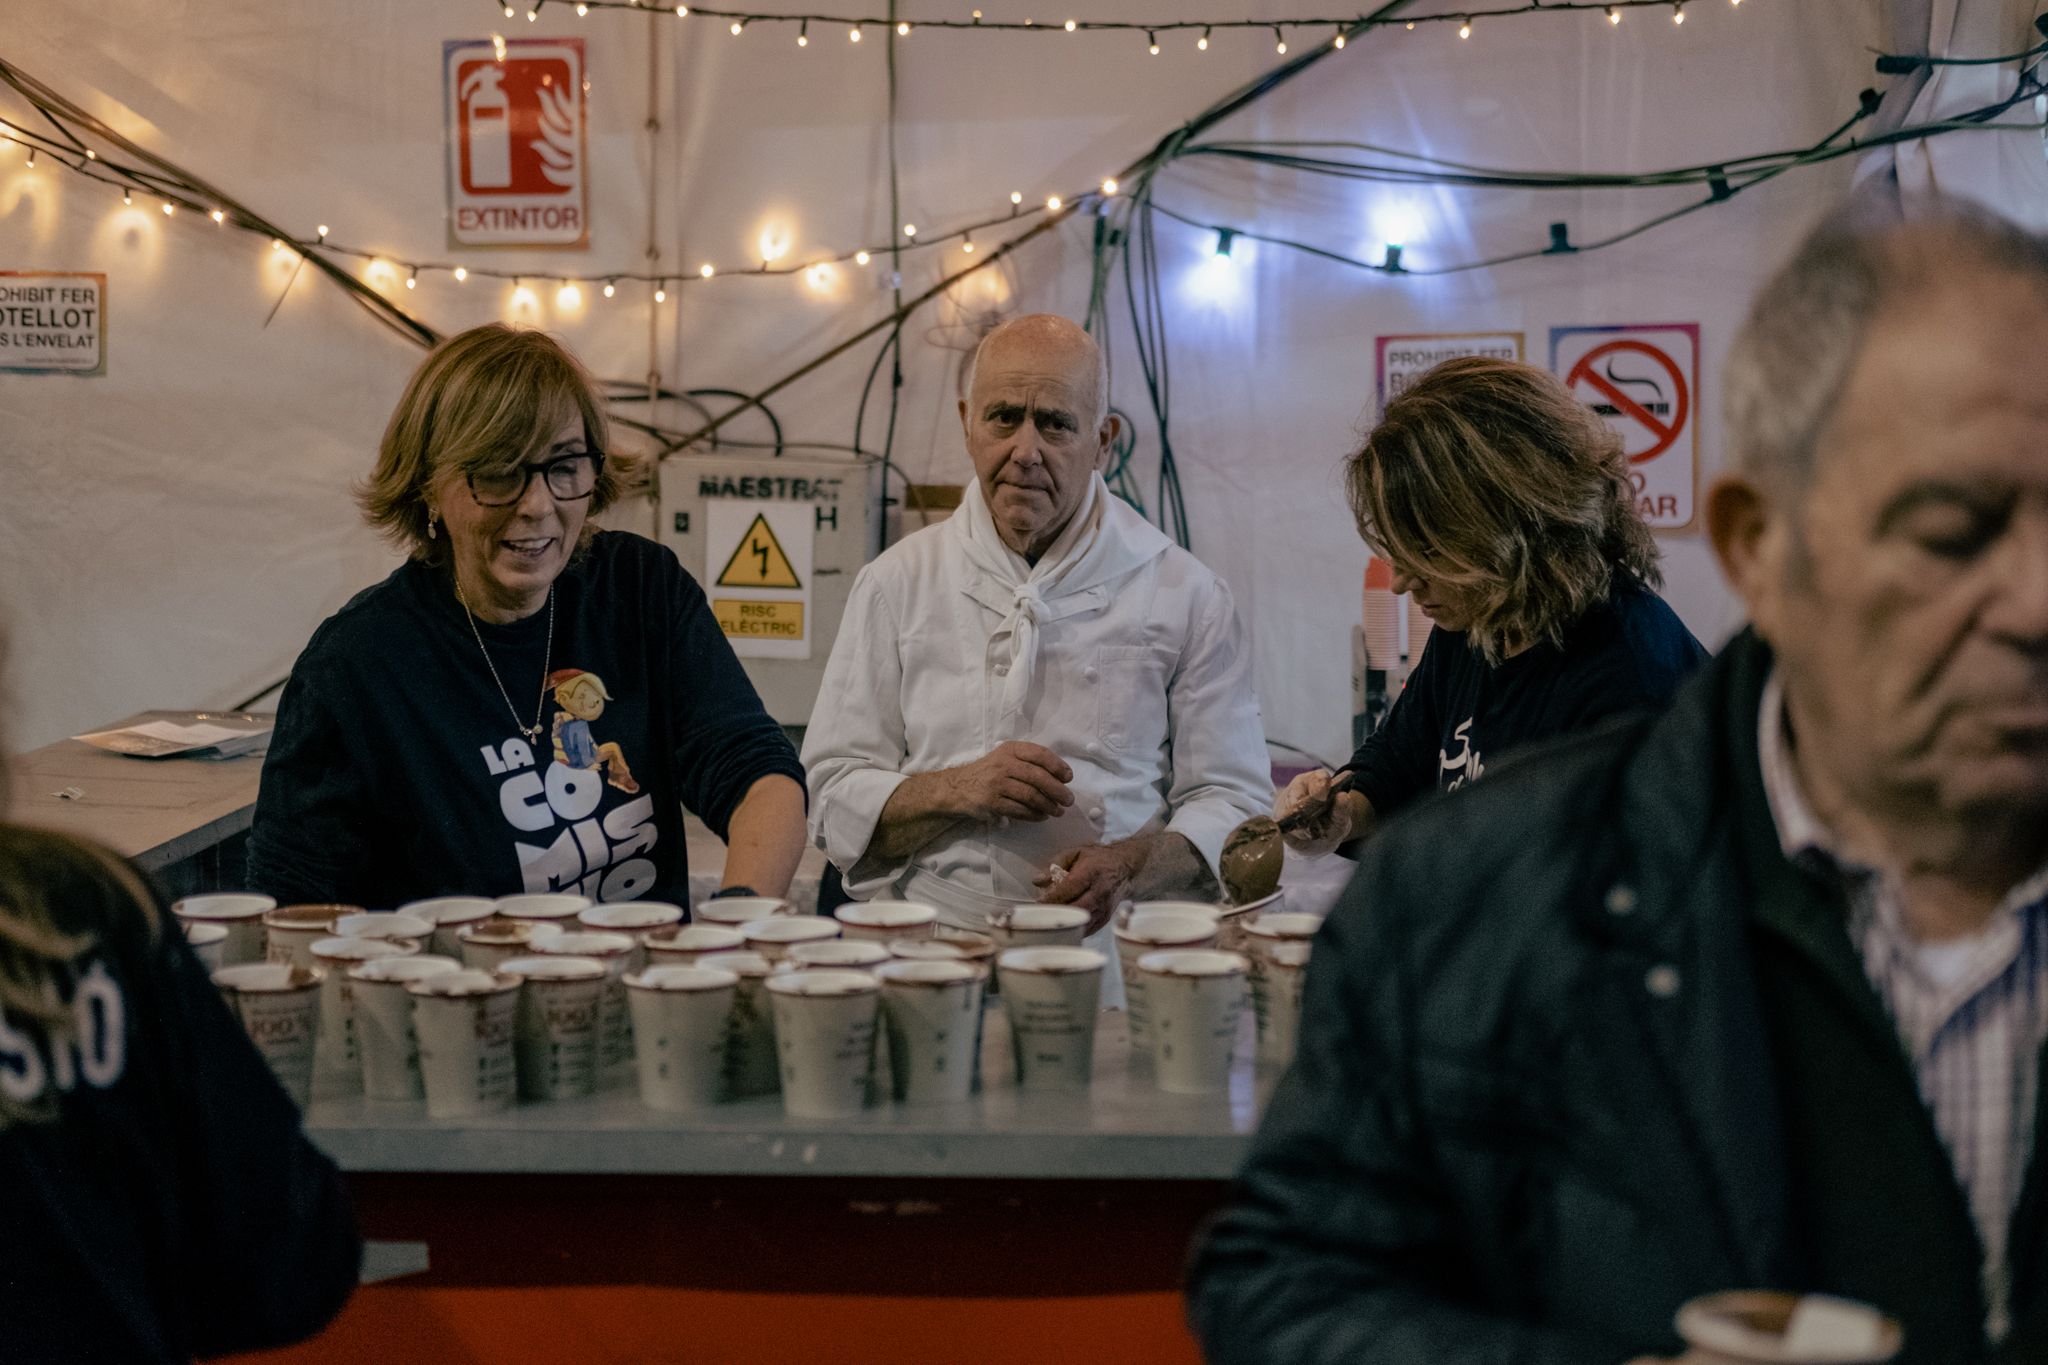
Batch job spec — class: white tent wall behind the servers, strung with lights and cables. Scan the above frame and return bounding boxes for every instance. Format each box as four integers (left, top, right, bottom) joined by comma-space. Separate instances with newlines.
0, 0, 2038, 757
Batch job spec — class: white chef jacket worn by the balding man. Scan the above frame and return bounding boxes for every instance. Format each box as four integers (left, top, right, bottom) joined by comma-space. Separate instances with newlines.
803, 475, 1272, 927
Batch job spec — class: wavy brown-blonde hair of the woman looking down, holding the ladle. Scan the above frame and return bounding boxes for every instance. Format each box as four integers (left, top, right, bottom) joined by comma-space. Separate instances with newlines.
1343, 356, 1663, 663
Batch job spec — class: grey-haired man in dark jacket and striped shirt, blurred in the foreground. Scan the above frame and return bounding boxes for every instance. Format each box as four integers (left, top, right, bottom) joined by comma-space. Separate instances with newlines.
1190, 213, 2048, 1365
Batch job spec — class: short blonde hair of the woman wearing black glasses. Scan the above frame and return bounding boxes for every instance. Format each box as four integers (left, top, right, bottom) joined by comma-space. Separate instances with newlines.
356, 323, 631, 565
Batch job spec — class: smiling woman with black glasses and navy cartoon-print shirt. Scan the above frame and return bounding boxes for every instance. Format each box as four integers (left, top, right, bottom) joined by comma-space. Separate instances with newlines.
248, 323, 805, 909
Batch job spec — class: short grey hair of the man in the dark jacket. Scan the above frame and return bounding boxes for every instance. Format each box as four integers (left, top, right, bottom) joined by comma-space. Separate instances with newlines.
1722, 203, 2048, 491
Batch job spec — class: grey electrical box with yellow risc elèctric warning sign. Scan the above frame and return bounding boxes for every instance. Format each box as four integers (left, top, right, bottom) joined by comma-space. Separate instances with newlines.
655, 454, 883, 724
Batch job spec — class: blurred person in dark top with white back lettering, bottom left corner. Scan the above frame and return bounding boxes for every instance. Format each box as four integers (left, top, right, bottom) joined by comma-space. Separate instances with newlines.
0, 646, 362, 1365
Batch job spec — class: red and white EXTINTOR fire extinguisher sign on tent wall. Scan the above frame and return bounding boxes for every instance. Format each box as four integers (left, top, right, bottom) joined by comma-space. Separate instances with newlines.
442, 39, 590, 248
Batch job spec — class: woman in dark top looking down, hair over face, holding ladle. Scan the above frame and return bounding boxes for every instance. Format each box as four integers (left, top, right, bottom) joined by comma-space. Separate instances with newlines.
1274, 356, 1706, 853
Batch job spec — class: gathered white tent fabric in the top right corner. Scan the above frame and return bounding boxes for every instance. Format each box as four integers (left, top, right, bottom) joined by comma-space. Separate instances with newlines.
1855, 0, 2048, 231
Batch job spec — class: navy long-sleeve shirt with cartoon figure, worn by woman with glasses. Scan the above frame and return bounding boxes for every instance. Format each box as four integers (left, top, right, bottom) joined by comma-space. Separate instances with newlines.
248, 532, 803, 909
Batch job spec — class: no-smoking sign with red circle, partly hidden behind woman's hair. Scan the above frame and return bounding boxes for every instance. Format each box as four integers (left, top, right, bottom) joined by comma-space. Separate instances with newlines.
1550, 323, 1700, 530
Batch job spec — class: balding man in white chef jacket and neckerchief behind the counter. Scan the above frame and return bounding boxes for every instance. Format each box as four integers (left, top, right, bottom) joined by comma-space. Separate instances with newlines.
803, 315, 1272, 931
